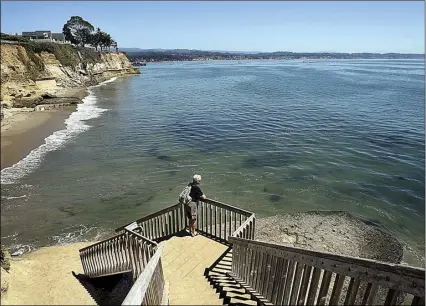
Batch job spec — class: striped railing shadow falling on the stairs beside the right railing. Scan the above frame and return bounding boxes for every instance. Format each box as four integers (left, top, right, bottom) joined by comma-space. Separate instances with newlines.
204, 247, 258, 306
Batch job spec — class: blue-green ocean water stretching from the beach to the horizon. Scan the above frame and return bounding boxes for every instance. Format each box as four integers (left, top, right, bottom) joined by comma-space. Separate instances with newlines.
1, 60, 425, 266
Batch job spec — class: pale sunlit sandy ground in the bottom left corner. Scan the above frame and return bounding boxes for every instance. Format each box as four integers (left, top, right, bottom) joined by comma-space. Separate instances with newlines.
1, 242, 95, 305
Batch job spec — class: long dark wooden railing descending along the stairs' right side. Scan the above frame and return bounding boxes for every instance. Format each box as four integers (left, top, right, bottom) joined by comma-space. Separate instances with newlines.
229, 237, 425, 305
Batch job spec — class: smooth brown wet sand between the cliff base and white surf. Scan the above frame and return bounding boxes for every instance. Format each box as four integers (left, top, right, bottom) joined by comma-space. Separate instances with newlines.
1, 106, 76, 169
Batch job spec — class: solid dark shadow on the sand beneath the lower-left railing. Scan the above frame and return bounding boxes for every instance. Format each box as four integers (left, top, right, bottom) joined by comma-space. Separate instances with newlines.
72, 271, 133, 305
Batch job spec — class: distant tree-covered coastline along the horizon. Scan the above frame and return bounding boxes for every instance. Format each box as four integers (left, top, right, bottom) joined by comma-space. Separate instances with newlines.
122, 49, 425, 64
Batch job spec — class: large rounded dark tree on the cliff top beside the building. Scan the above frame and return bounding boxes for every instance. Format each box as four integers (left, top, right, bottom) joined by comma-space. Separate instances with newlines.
62, 16, 95, 46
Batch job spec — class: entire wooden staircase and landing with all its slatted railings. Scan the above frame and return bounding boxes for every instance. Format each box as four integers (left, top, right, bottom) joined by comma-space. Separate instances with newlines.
80, 199, 425, 306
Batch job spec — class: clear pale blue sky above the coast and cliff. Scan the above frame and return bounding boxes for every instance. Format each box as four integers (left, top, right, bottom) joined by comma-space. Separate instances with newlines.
1, 1, 425, 53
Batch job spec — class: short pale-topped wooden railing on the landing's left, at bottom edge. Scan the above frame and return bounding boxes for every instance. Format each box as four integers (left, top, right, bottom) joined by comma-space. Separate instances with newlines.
122, 246, 164, 305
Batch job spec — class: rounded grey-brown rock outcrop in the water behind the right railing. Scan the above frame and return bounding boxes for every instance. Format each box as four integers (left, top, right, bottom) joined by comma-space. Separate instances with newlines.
255, 211, 404, 263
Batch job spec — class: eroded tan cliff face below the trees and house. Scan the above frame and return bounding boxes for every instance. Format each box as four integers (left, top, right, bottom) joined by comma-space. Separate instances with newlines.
1, 44, 140, 107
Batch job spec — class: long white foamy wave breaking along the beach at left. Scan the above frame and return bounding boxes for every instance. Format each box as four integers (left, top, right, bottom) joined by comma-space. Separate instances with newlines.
1, 77, 117, 185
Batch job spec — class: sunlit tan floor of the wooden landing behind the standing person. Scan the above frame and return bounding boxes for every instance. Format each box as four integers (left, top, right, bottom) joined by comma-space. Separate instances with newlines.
161, 235, 227, 305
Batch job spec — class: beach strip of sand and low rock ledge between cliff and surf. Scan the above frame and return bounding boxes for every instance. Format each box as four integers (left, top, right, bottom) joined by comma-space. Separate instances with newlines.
1, 87, 89, 170
